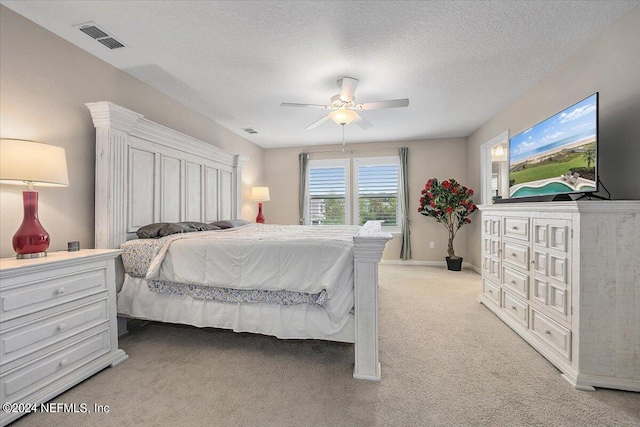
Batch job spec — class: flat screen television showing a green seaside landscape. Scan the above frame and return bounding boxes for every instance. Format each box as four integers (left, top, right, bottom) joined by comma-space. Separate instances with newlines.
509, 92, 598, 201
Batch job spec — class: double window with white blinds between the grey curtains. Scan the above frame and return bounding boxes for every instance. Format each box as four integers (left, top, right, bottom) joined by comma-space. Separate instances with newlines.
305, 157, 400, 232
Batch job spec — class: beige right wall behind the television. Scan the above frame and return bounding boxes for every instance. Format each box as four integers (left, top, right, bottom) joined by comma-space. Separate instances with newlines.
468, 7, 640, 266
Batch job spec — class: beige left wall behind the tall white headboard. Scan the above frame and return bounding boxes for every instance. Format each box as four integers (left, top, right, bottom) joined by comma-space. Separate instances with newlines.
0, 6, 264, 257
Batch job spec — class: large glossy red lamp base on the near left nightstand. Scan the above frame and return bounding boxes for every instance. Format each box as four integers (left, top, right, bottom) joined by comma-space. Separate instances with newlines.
13, 191, 49, 258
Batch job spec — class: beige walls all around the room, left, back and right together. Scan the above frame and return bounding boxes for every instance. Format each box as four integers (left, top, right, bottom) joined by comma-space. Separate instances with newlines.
0, 6, 640, 266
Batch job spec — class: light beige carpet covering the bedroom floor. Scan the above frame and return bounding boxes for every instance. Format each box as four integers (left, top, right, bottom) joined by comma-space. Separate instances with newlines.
14, 265, 640, 427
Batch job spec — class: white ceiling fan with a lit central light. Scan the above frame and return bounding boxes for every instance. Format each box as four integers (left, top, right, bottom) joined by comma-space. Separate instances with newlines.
280, 77, 409, 130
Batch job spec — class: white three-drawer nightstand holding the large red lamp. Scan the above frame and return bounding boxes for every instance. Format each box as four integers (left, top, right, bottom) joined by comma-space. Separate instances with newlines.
0, 249, 128, 426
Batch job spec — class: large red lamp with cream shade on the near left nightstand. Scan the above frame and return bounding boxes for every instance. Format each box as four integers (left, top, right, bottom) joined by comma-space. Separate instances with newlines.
0, 139, 69, 258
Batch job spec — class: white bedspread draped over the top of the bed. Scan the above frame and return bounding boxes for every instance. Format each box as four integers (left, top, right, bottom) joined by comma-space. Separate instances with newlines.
141, 224, 359, 324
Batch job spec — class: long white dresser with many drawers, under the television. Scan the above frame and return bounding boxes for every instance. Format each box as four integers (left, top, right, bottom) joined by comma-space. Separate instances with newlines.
478, 201, 640, 391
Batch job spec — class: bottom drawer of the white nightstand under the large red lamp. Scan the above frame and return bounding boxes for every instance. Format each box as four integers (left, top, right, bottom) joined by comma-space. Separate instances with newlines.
0, 329, 109, 402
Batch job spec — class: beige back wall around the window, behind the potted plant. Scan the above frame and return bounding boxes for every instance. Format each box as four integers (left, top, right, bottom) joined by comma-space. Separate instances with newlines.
264, 139, 475, 262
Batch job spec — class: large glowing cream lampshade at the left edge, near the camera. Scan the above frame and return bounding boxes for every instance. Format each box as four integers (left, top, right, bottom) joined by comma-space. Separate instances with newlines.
0, 139, 69, 187
